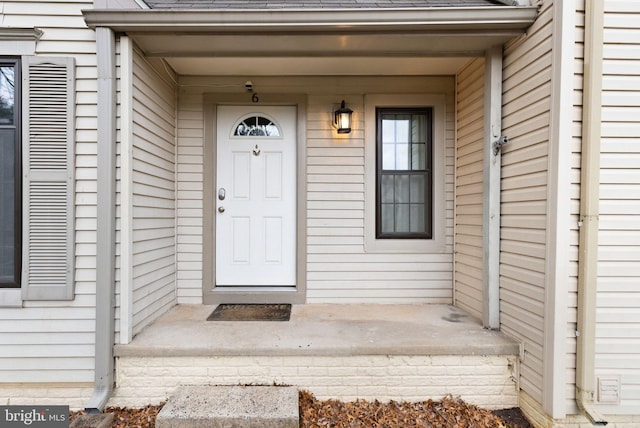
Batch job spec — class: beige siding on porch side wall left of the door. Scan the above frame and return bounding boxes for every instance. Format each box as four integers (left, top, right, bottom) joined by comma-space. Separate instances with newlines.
131, 49, 176, 334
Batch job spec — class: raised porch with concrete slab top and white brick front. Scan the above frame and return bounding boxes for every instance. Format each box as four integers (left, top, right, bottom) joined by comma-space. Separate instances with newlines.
110, 304, 519, 409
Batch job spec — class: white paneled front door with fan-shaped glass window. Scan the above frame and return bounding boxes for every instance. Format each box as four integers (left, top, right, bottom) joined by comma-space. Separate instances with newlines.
215, 106, 296, 287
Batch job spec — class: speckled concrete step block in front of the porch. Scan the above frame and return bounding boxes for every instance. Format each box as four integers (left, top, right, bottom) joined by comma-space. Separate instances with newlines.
156, 386, 299, 428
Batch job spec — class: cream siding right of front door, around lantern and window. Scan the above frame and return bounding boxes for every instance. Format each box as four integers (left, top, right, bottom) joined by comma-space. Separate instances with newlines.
307, 87, 454, 303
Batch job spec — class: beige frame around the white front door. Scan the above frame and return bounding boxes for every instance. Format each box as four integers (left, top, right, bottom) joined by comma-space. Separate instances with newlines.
202, 94, 307, 304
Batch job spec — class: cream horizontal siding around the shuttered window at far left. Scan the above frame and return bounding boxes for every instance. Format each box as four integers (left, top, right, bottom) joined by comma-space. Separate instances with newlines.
0, 0, 96, 383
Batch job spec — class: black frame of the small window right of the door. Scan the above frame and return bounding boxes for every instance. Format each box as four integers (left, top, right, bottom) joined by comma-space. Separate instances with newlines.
376, 106, 434, 239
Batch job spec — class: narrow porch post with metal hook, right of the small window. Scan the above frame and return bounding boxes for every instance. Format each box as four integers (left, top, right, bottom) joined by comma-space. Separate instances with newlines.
482, 46, 502, 329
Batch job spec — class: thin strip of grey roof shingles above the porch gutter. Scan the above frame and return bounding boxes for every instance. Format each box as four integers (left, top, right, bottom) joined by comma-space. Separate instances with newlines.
144, 0, 505, 10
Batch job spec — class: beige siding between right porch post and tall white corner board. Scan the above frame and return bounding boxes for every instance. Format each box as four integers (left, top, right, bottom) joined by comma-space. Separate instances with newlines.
500, 1, 552, 403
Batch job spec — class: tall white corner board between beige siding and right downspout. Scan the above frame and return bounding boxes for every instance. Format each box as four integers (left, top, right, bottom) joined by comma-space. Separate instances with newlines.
542, 1, 575, 419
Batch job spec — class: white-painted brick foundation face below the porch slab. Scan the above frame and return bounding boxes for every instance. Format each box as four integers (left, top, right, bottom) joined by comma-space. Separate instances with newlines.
109, 355, 518, 409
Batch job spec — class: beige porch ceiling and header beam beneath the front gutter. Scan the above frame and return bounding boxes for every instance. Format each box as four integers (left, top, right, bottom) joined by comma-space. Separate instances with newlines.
129, 32, 514, 76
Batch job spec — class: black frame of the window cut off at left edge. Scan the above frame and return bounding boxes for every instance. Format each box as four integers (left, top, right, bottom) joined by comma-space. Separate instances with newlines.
0, 56, 22, 288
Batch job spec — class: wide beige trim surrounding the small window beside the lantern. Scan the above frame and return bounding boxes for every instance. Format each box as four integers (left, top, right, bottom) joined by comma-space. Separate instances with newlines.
364, 94, 446, 253
